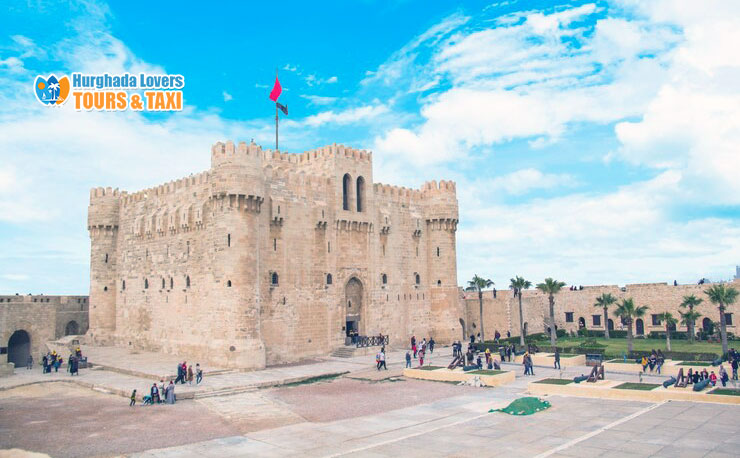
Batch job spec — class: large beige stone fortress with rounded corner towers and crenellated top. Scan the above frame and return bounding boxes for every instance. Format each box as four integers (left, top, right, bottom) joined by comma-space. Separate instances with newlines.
88, 142, 463, 368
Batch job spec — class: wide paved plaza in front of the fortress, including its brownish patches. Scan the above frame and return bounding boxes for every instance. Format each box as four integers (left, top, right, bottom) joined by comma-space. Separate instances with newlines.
0, 348, 740, 457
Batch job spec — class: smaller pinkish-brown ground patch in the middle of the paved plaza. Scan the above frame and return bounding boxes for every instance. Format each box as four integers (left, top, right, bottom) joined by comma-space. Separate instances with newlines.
267, 378, 481, 422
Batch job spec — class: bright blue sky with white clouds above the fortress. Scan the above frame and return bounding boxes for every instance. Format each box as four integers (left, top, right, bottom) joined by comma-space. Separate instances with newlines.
0, 0, 740, 294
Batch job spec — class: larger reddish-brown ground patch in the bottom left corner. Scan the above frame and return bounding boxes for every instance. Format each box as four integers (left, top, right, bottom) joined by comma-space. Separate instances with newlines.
0, 384, 238, 457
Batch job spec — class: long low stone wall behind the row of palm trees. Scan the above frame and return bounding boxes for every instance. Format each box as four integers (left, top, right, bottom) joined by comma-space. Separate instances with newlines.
460, 278, 740, 339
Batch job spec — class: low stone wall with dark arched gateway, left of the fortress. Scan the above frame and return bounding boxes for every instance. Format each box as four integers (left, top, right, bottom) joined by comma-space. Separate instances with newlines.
0, 295, 89, 365
